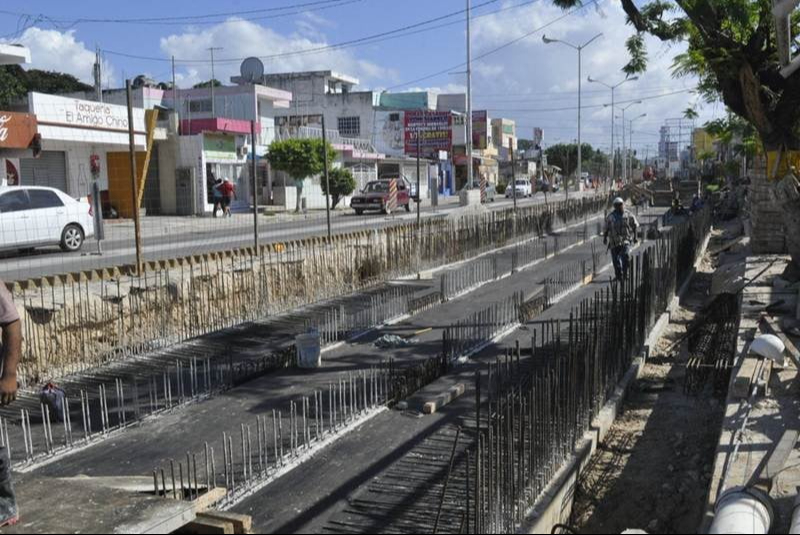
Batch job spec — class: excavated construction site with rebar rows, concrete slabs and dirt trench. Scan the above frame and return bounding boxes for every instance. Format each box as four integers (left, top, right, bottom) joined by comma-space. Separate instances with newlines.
0, 166, 788, 533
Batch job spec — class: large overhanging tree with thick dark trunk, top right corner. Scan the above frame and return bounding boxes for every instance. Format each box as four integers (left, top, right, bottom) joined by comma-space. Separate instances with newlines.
553, 0, 800, 151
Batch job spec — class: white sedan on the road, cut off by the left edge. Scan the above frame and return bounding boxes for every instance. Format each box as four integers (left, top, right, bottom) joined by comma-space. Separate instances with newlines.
0, 186, 94, 252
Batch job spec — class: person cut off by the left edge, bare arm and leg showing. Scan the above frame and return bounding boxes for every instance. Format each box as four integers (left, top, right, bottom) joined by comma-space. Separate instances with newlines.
0, 280, 22, 528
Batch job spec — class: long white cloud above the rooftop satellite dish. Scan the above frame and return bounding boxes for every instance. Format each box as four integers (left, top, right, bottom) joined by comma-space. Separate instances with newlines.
161, 18, 398, 86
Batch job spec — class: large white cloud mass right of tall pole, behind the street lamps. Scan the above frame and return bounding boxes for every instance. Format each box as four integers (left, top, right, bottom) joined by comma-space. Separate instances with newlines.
473, 0, 719, 150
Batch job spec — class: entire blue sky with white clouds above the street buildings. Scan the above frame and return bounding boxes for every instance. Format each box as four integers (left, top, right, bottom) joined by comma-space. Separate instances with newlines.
0, 0, 723, 152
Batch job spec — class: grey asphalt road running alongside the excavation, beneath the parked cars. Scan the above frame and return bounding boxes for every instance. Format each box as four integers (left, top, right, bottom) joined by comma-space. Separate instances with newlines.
0, 192, 593, 282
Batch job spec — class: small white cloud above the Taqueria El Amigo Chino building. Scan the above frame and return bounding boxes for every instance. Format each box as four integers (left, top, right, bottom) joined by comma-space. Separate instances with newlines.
2, 27, 115, 85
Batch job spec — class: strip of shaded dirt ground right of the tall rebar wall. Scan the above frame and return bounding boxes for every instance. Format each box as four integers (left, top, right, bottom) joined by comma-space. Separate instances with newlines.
571, 236, 724, 533
